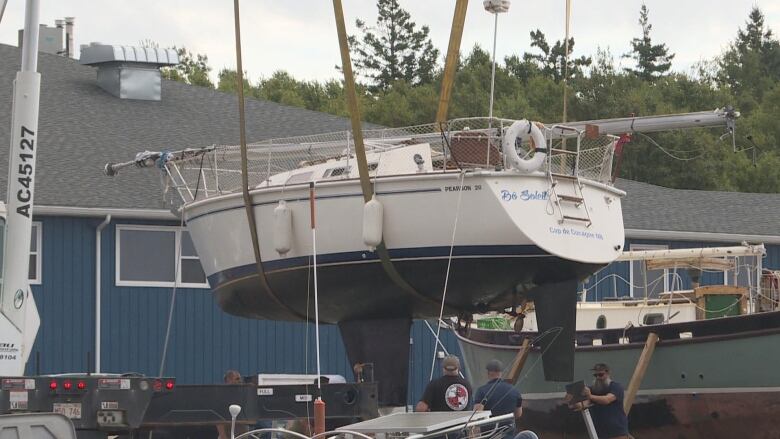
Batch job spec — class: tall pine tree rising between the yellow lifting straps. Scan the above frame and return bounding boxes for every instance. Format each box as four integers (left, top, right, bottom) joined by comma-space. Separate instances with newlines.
349, 0, 439, 91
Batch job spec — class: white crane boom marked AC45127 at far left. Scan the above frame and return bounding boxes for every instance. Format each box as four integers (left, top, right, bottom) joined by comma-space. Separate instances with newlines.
0, 0, 41, 375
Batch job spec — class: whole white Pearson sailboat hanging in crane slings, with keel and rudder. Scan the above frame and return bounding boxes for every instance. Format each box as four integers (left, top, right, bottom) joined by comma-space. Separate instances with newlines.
106, 110, 736, 403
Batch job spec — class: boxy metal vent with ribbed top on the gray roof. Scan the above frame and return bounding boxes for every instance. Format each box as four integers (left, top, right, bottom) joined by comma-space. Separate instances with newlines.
79, 43, 179, 101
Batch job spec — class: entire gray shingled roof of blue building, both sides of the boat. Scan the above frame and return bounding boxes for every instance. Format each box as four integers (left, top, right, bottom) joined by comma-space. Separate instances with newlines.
0, 44, 780, 236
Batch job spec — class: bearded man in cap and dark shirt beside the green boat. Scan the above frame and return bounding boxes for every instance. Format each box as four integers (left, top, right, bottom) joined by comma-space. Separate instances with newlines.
583, 363, 629, 439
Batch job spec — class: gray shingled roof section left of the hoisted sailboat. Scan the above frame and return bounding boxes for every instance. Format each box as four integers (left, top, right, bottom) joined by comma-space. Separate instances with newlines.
0, 44, 372, 209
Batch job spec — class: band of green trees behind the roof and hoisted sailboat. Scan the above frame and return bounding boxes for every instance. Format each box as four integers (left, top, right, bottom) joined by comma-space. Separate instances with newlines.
180, 6, 780, 192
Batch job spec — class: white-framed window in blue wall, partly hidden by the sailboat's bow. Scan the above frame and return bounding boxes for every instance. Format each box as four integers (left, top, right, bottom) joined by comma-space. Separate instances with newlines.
116, 225, 209, 288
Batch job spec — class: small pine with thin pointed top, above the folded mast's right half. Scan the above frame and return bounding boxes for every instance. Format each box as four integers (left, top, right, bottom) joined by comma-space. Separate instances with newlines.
623, 4, 674, 82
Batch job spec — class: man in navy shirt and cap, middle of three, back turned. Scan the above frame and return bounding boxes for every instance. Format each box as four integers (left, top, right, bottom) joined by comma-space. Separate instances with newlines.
474, 360, 523, 438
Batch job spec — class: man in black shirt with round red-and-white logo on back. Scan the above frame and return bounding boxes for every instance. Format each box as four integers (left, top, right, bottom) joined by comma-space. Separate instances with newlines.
415, 355, 471, 412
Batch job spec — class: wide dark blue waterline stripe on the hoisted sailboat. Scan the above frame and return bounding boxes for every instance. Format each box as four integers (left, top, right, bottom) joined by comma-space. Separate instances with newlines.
209, 245, 551, 288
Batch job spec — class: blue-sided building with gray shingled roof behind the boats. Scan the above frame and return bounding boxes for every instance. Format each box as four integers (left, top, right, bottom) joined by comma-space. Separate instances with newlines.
0, 45, 780, 403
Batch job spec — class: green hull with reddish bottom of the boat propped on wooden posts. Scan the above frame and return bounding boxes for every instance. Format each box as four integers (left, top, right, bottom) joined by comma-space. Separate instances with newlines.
458, 313, 780, 438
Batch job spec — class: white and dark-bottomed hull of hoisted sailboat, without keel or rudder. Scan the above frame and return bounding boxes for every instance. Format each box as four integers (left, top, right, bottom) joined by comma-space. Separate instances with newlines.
184, 171, 624, 323
